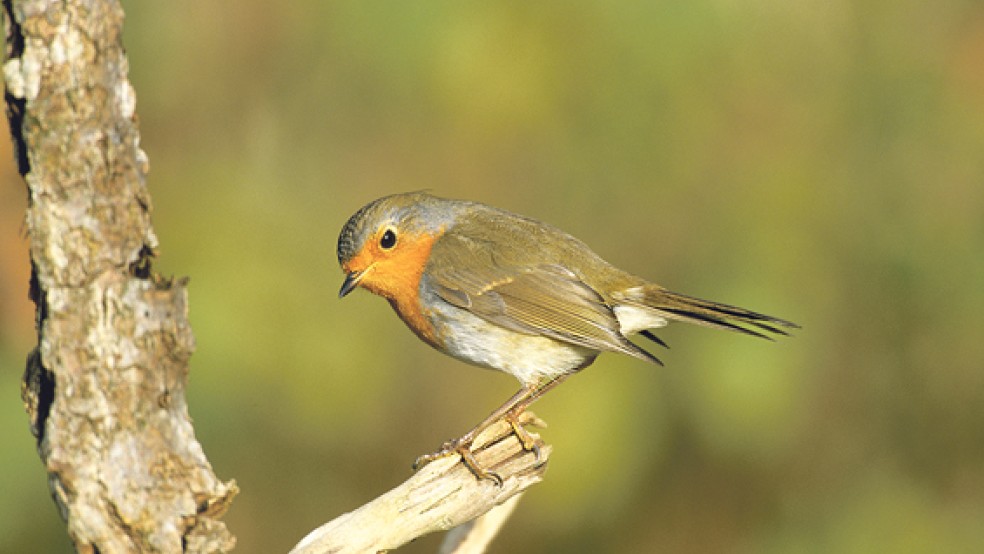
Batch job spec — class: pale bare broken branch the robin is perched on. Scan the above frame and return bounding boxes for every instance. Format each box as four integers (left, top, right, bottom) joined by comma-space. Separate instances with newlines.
291, 413, 551, 554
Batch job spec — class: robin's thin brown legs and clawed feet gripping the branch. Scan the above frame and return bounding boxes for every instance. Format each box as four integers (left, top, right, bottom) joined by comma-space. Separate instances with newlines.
413, 374, 567, 485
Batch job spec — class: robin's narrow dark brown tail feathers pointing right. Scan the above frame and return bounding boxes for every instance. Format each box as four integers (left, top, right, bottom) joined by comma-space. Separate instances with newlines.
632, 286, 799, 340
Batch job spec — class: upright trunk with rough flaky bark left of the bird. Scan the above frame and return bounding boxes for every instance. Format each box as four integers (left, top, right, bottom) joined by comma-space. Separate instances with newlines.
3, 0, 237, 554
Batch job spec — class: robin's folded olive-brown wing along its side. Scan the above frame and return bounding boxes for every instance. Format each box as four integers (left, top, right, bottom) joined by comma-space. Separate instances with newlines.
427, 233, 661, 363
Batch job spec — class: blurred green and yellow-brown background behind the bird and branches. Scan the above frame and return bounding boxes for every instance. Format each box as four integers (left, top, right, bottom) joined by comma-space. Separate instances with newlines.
0, 0, 984, 553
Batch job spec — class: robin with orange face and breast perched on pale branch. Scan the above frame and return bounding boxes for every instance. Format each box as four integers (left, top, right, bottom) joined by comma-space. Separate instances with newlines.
338, 192, 797, 482
